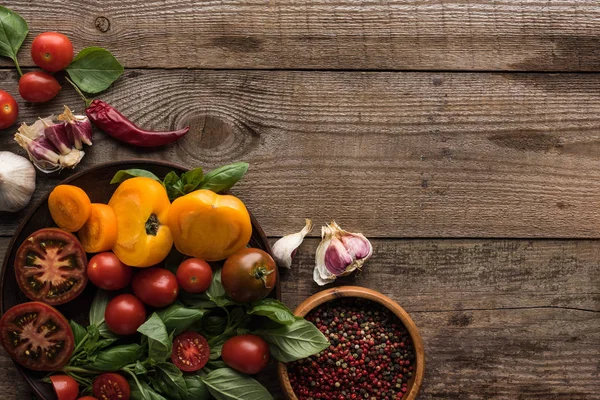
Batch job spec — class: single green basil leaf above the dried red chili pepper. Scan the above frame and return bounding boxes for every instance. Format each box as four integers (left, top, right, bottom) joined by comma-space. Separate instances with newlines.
66, 47, 123, 93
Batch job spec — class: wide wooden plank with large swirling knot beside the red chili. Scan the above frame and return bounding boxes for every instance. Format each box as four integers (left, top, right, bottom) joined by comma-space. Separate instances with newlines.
0, 70, 600, 238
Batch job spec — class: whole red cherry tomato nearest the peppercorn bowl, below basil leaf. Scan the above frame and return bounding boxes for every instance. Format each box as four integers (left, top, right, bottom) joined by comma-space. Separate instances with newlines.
221, 335, 269, 375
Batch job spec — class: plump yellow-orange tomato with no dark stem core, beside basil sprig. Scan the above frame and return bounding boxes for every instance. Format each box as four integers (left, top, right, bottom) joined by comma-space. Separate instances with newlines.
168, 190, 252, 261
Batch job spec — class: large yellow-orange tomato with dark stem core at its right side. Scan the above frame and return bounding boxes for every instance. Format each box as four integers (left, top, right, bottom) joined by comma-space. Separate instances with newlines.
108, 177, 173, 267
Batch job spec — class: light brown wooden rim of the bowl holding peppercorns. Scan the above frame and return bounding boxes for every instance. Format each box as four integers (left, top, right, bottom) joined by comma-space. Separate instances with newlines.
277, 286, 425, 400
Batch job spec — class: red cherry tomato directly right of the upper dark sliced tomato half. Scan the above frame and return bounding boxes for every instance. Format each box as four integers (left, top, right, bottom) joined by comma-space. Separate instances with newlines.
87, 252, 133, 290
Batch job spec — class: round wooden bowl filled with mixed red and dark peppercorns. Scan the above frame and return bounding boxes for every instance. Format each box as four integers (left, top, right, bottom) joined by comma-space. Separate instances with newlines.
278, 286, 425, 400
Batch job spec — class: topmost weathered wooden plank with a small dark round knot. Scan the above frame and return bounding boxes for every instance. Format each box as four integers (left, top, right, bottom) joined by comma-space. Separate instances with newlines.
3, 0, 600, 71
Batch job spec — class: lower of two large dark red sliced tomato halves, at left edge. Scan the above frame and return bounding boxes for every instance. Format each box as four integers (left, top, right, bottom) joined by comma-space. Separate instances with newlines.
0, 301, 74, 371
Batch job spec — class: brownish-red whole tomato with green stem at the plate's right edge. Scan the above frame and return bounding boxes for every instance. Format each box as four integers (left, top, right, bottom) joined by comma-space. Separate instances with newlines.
221, 248, 277, 303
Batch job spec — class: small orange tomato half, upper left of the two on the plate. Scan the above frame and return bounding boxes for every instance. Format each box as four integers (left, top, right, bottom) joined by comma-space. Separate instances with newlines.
48, 185, 92, 232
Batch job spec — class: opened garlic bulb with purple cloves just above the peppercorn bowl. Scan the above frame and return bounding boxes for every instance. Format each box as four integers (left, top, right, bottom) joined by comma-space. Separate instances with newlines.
313, 221, 373, 286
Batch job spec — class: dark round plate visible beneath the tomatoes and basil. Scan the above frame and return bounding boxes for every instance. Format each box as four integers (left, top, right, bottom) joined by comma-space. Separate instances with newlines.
0, 160, 280, 400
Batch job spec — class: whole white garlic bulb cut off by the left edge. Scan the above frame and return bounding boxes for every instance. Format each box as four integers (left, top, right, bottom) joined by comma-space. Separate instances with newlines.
0, 151, 35, 212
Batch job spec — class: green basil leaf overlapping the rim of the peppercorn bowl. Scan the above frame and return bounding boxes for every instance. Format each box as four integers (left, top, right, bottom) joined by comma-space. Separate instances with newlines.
256, 318, 329, 362
